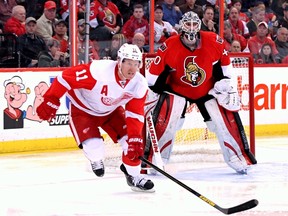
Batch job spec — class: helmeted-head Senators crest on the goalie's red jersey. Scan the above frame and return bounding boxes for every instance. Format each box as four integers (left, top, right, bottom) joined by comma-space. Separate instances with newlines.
181, 56, 206, 87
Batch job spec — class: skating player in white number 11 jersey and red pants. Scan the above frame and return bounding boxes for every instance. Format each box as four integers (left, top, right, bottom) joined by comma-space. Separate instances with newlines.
37, 44, 154, 192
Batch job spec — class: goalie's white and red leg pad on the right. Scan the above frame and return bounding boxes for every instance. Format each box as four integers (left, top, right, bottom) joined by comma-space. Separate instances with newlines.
205, 99, 252, 173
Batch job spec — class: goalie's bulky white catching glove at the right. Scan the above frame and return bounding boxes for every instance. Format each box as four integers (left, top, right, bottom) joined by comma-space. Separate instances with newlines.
208, 79, 240, 111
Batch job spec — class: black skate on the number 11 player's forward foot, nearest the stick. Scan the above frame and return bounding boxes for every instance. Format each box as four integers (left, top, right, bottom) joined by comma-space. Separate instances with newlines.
120, 164, 155, 193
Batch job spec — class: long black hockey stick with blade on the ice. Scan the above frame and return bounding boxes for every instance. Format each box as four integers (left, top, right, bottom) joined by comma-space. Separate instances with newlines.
139, 156, 258, 214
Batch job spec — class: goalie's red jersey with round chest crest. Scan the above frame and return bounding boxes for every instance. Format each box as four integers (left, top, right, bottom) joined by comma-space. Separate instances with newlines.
148, 31, 230, 100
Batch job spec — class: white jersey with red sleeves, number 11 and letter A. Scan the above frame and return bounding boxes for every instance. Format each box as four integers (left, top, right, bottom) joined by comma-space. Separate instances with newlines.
45, 60, 148, 122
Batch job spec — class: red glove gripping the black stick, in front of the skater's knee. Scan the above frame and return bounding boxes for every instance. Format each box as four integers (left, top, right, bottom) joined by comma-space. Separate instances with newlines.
127, 137, 143, 160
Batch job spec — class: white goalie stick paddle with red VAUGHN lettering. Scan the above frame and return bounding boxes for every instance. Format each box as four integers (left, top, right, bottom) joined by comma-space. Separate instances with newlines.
143, 112, 164, 168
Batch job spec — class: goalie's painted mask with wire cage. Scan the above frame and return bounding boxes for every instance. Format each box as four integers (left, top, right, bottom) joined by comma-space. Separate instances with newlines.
180, 11, 201, 41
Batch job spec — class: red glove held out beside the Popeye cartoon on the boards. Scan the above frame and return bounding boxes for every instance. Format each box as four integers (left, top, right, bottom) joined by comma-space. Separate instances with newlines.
36, 96, 60, 121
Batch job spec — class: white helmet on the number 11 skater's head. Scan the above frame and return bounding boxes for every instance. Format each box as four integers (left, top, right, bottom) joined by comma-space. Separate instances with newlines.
118, 43, 142, 67
